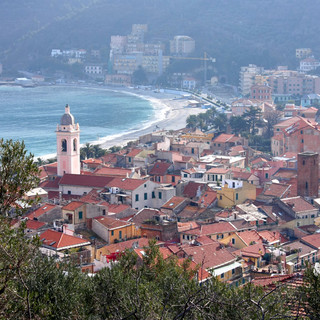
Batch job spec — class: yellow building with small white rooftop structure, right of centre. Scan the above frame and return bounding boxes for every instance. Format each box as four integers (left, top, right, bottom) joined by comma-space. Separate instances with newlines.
217, 180, 256, 208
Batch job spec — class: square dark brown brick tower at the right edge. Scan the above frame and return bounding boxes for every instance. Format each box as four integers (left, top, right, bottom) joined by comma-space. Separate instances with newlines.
297, 152, 319, 198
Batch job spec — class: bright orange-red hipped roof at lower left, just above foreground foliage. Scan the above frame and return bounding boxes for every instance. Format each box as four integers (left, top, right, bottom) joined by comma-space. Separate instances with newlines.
40, 230, 90, 250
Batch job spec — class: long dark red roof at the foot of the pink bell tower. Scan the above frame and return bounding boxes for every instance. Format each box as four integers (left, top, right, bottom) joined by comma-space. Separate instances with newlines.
59, 173, 113, 188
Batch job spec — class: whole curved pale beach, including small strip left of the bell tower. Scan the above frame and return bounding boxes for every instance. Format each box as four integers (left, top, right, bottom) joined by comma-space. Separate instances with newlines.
37, 86, 206, 160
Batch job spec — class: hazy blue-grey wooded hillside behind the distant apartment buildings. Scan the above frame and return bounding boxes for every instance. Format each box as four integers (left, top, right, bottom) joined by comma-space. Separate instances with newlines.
0, 0, 320, 82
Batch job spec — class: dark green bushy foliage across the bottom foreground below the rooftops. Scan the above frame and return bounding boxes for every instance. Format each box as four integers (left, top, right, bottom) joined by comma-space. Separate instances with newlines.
0, 225, 312, 320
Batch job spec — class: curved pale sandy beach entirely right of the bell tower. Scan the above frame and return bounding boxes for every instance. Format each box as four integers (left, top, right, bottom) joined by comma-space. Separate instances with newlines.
100, 89, 205, 149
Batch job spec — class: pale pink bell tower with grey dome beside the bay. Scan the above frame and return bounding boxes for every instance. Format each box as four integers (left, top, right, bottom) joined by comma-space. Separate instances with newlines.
56, 105, 80, 177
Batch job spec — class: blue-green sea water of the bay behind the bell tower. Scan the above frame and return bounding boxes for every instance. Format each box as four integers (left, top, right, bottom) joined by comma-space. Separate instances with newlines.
0, 86, 154, 156
